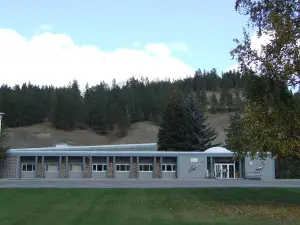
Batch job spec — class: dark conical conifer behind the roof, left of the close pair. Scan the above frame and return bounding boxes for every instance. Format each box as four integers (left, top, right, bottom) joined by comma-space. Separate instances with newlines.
157, 90, 191, 151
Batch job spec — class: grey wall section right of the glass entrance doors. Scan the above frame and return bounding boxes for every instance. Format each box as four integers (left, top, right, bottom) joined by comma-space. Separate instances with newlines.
244, 157, 275, 179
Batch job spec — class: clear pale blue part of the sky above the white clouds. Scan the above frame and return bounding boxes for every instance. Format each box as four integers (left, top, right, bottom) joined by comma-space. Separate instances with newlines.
0, 0, 247, 87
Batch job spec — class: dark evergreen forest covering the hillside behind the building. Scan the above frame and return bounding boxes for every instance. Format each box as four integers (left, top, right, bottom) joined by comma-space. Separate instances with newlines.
0, 69, 246, 147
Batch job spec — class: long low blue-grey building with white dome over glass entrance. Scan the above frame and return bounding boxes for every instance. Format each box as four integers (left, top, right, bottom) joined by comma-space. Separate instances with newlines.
0, 143, 275, 180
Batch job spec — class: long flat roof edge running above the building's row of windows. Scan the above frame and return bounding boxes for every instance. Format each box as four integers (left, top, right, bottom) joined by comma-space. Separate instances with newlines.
7, 150, 234, 157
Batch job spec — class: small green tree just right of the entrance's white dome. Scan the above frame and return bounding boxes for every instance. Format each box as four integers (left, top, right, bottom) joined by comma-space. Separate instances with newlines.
224, 111, 245, 157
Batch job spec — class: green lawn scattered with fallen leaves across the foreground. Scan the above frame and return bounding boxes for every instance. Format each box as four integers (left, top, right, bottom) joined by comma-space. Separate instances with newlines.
0, 188, 300, 225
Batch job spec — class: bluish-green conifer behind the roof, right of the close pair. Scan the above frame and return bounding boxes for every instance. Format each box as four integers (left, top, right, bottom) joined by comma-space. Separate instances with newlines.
184, 92, 220, 152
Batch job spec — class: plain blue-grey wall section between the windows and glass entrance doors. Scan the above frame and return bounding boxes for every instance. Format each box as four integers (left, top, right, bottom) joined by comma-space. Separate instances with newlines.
177, 156, 207, 179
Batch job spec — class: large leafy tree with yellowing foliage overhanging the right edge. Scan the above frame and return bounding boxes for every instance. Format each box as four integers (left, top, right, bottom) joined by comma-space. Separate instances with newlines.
231, 0, 300, 157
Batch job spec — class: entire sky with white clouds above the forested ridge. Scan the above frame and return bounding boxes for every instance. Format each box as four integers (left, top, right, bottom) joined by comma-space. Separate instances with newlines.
0, 0, 262, 86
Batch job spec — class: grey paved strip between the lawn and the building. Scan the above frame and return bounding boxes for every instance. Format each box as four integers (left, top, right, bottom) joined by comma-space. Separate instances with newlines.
0, 179, 300, 188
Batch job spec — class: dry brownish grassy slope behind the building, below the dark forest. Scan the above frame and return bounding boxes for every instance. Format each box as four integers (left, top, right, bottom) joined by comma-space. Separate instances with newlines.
8, 114, 228, 148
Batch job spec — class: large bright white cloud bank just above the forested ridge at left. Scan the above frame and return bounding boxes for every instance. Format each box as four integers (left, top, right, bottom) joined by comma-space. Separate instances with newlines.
0, 29, 195, 89
